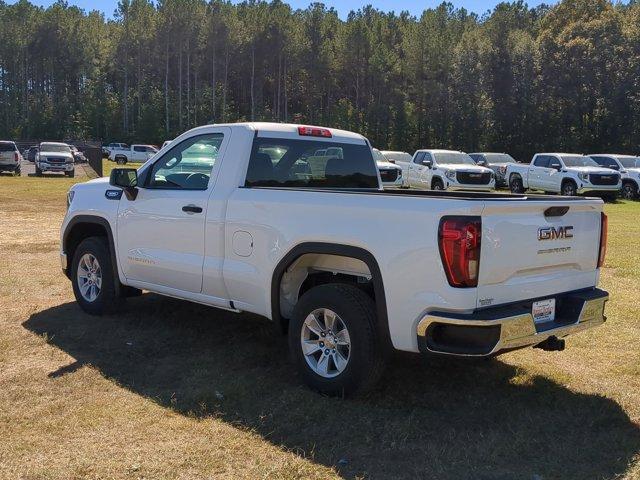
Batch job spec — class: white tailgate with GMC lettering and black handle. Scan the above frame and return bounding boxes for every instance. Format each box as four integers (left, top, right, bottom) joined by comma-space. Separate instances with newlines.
477, 199, 602, 308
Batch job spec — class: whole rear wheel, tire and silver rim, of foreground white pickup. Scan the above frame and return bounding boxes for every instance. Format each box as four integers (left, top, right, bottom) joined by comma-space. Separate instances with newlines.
289, 284, 385, 395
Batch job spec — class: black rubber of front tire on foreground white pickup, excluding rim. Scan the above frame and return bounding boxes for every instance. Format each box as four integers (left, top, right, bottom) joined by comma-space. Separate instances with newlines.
71, 237, 122, 315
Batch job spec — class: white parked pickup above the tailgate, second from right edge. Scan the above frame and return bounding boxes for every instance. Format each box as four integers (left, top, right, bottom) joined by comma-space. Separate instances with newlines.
506, 153, 622, 197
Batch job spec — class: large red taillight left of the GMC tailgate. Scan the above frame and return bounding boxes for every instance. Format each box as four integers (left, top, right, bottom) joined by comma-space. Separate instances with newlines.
438, 216, 482, 288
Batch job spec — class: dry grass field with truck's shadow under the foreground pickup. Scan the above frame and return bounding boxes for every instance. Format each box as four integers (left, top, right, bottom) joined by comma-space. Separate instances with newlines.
0, 173, 640, 480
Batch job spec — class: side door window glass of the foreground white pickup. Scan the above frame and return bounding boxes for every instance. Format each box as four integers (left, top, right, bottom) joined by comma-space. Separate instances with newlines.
146, 133, 223, 190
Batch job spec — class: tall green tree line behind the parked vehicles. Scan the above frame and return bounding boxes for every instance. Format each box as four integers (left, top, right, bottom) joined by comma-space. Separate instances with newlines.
0, 0, 640, 160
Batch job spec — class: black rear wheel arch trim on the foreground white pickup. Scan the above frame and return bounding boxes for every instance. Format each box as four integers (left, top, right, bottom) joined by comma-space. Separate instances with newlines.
271, 242, 392, 348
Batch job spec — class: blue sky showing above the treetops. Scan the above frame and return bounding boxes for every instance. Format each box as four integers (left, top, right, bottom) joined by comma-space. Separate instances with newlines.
8, 0, 555, 18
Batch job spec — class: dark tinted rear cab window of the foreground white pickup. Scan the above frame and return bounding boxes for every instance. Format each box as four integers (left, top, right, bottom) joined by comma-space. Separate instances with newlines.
245, 137, 378, 189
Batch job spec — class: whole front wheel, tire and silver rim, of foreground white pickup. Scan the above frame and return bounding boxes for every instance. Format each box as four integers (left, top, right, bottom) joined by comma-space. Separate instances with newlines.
71, 237, 121, 315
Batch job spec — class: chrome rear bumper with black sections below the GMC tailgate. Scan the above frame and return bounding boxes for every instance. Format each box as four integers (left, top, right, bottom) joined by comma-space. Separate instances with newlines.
417, 289, 609, 357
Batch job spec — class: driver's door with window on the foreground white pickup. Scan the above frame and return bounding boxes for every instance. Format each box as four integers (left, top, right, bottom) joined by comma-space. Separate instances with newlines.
117, 131, 224, 293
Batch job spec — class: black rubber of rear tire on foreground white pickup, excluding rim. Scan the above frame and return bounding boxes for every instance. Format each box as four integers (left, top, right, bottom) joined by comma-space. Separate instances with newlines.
289, 283, 386, 396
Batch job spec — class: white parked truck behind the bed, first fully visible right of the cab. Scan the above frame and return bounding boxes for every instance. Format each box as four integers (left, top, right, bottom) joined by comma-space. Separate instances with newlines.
404, 150, 495, 191
